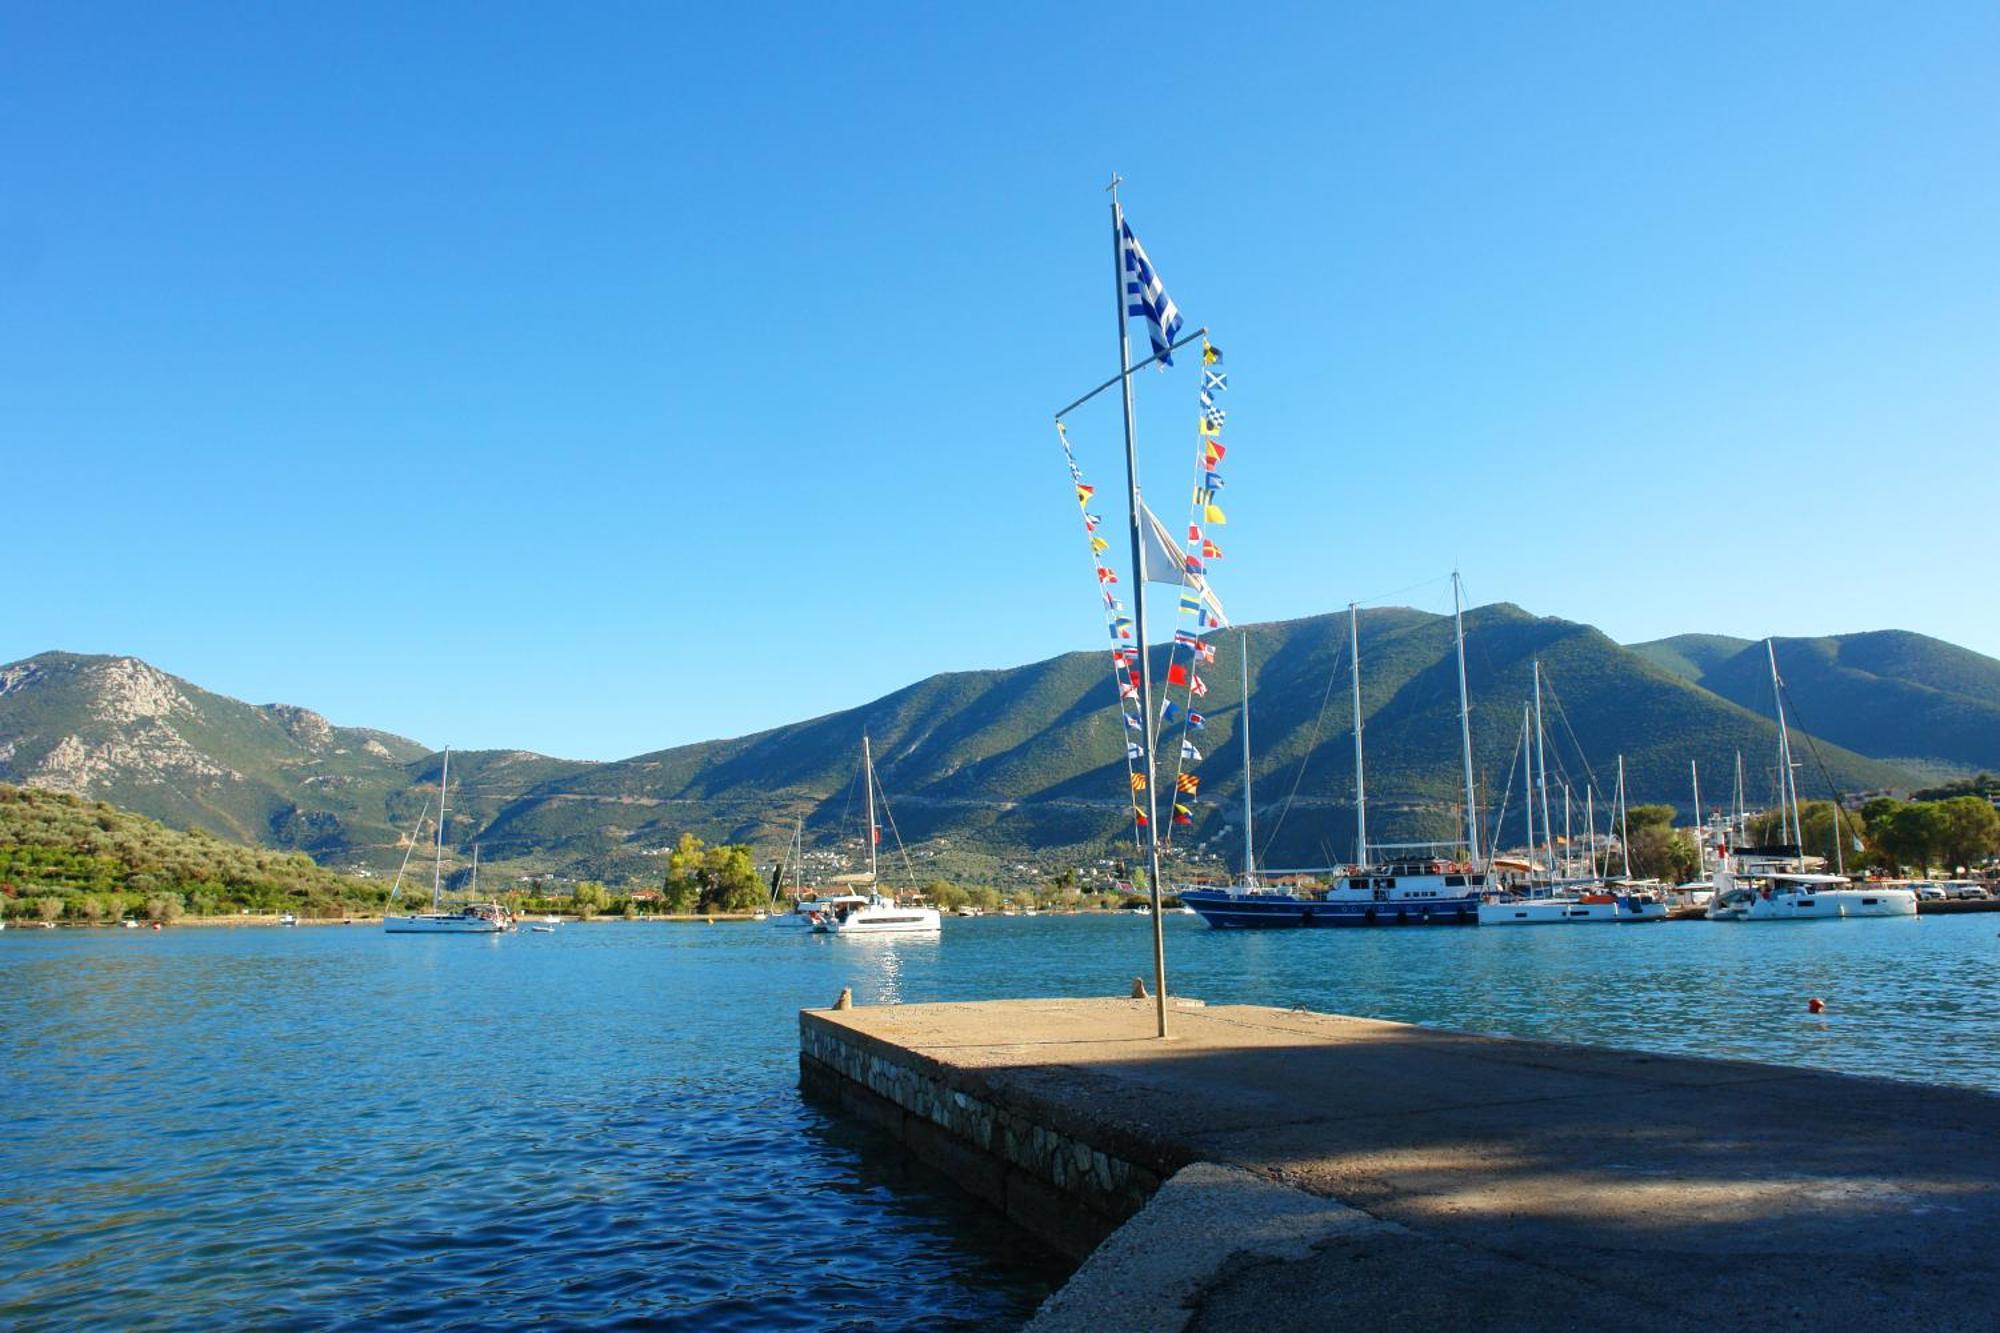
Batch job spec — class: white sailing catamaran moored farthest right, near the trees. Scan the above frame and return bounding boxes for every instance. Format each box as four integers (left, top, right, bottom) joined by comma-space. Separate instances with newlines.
1706, 638, 1916, 921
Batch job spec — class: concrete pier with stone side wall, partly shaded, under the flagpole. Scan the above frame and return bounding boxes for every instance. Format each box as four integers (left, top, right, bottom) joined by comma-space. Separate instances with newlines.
800, 999, 2000, 1333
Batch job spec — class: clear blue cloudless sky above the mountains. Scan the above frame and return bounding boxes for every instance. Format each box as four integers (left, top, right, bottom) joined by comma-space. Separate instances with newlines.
0, 4, 2000, 759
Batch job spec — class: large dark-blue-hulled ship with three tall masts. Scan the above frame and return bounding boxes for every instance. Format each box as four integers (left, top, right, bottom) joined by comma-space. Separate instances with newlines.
1180, 572, 1488, 931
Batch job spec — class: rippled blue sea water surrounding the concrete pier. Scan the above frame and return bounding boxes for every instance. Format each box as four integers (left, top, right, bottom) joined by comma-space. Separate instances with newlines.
0, 915, 2000, 1329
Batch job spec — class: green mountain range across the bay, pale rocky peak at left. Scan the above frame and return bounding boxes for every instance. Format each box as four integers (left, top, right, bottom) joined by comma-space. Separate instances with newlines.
0, 604, 2000, 879
